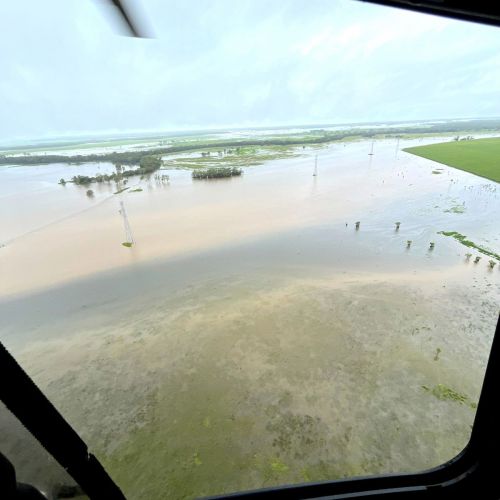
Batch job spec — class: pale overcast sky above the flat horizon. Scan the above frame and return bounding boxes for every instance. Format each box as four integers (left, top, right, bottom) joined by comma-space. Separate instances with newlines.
0, 0, 500, 144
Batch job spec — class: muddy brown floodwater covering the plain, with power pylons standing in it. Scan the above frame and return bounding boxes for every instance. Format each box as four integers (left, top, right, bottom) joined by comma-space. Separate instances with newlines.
0, 138, 500, 498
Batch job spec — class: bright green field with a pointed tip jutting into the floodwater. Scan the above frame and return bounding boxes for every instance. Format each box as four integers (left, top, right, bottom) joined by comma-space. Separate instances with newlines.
403, 137, 500, 182
